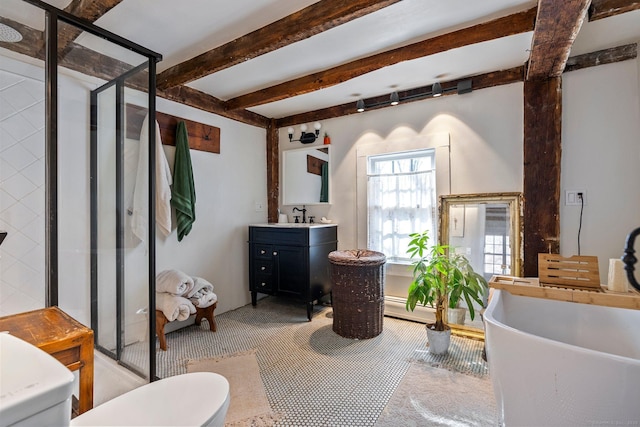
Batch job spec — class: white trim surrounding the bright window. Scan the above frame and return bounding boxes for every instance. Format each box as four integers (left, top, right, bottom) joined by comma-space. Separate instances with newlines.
356, 132, 451, 270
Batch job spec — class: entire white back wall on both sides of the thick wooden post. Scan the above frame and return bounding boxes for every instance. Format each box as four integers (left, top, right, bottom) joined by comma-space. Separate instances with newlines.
280, 59, 640, 296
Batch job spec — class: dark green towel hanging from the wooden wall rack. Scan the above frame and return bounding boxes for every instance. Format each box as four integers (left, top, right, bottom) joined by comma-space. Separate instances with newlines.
171, 121, 196, 242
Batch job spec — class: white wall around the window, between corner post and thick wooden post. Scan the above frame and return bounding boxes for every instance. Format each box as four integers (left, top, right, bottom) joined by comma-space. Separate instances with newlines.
280, 83, 523, 296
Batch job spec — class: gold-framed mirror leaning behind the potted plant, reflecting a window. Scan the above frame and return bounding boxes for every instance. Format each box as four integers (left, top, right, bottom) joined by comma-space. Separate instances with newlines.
440, 193, 522, 335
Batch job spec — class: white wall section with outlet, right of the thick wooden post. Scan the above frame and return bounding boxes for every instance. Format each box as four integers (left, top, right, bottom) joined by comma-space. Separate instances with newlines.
560, 59, 640, 283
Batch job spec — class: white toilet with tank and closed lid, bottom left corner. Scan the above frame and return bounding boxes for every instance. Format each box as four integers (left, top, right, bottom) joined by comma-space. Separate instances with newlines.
0, 333, 229, 427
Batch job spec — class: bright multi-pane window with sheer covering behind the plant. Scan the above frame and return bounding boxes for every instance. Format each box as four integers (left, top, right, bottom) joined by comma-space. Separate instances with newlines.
367, 149, 437, 262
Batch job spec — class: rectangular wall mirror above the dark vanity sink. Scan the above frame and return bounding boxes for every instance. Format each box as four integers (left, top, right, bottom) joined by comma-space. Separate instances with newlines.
282, 145, 331, 205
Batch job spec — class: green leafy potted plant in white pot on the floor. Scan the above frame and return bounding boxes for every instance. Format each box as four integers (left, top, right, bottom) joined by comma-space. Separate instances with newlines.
406, 231, 487, 354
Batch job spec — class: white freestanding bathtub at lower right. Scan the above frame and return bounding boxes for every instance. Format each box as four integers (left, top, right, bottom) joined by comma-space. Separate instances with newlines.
484, 289, 640, 427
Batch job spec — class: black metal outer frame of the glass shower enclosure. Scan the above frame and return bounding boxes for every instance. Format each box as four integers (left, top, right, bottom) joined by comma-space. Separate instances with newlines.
22, 0, 162, 381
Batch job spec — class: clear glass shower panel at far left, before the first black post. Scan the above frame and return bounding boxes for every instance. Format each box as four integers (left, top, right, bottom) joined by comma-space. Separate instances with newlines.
0, 0, 46, 316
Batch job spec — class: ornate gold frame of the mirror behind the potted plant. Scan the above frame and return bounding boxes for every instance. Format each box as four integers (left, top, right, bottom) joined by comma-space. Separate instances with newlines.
438, 192, 524, 339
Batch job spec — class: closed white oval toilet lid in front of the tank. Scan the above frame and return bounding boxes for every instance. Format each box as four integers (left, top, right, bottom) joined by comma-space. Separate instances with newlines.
70, 372, 229, 426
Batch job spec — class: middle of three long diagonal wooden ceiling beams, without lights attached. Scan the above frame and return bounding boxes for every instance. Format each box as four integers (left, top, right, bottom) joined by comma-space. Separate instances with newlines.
227, 8, 536, 109
